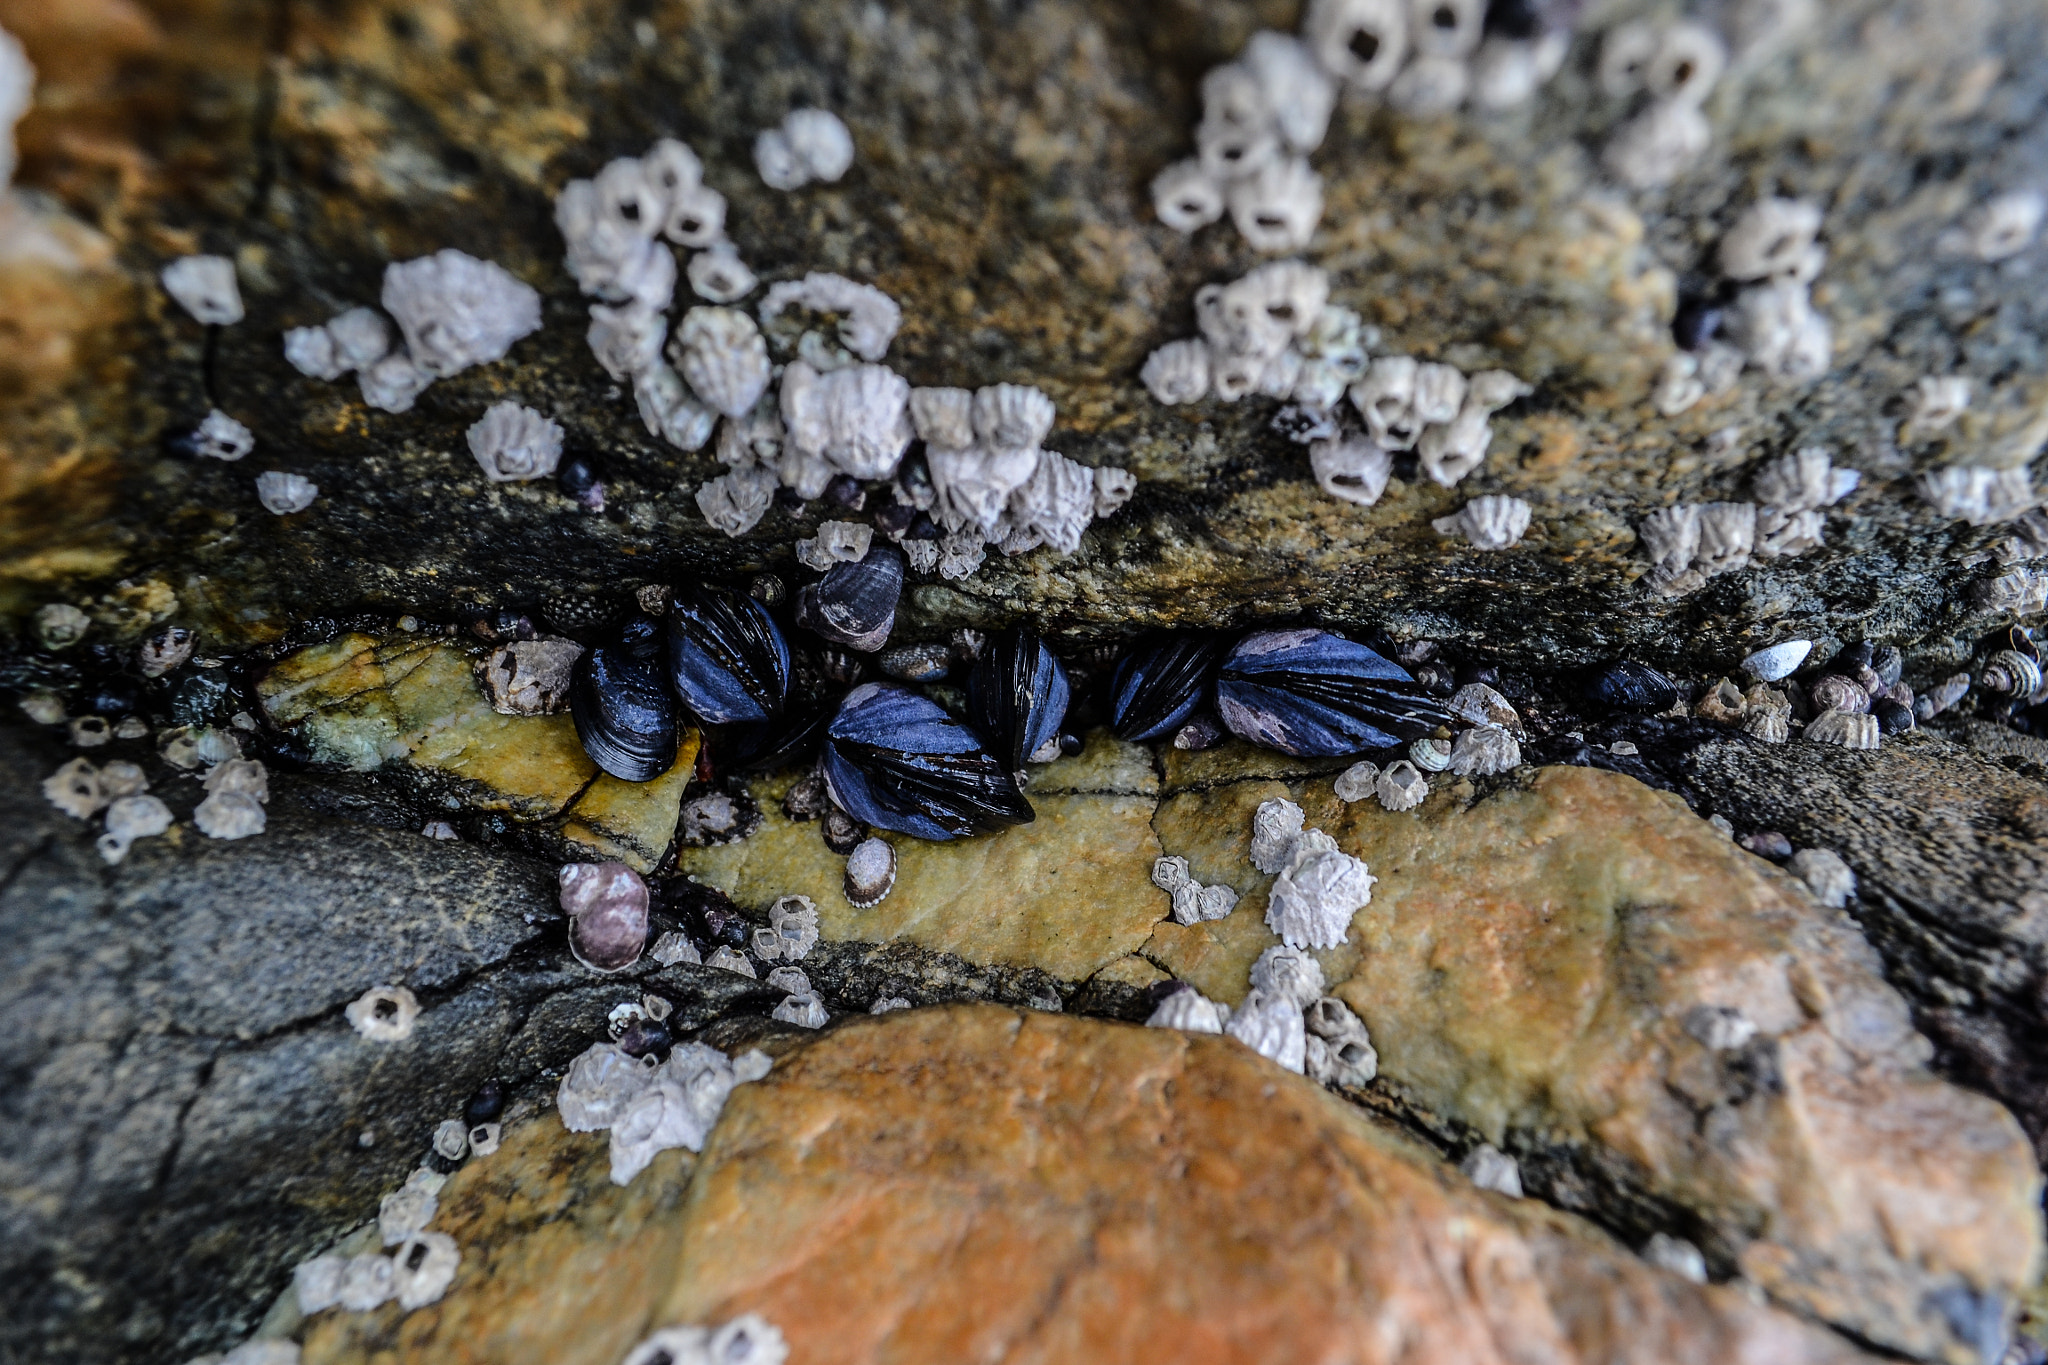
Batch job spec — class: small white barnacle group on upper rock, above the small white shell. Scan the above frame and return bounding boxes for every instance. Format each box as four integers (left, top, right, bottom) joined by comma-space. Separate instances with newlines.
1636, 446, 1862, 596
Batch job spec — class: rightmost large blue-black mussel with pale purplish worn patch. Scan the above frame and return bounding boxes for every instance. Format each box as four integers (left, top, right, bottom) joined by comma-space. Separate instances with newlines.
1217, 630, 1450, 757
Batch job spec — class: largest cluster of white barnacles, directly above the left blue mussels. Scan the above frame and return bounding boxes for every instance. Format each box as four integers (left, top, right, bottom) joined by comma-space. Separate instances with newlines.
555, 129, 1135, 579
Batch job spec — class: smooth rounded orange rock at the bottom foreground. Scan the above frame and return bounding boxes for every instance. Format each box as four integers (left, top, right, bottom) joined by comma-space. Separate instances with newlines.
305, 1007, 1870, 1365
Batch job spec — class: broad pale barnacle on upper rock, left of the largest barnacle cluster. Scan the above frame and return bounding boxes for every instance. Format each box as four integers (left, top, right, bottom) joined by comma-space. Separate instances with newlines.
383, 248, 541, 379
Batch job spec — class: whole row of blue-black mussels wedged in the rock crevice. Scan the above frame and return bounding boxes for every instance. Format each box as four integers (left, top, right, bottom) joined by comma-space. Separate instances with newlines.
569, 568, 1452, 839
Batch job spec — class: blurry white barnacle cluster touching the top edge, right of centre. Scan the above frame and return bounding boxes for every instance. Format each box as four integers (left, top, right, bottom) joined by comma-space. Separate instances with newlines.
1151, 0, 1571, 252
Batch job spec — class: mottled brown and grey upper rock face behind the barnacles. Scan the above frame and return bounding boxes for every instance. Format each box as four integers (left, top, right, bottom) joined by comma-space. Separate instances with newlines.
0, 0, 2048, 659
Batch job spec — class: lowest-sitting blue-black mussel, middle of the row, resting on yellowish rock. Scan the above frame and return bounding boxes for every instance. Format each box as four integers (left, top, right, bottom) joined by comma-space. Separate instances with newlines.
823, 684, 1032, 839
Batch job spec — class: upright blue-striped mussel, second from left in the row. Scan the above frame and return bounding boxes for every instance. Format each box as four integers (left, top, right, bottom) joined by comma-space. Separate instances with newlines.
666, 585, 788, 724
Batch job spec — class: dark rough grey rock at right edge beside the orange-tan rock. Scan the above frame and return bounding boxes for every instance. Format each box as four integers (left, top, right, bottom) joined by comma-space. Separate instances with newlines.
1688, 726, 2048, 1164
